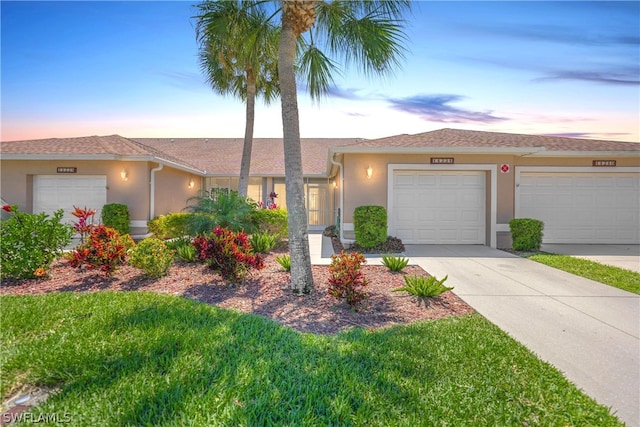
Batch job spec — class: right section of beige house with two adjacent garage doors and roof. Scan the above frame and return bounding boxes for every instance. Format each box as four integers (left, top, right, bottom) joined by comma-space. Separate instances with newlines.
327, 129, 640, 247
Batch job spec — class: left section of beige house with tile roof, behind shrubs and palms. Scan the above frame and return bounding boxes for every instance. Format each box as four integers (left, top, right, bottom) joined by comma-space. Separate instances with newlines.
0, 135, 353, 234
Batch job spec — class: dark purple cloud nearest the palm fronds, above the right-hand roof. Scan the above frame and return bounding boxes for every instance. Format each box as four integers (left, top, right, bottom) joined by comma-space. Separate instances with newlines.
388, 94, 508, 123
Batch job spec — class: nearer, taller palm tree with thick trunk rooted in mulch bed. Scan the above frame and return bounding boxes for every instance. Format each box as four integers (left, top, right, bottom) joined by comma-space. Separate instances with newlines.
278, 0, 411, 294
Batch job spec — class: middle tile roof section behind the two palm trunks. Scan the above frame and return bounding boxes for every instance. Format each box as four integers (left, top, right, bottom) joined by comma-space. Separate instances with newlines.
134, 138, 356, 176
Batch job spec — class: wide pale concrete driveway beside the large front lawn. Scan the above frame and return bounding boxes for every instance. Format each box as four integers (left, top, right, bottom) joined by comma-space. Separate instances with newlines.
404, 245, 640, 426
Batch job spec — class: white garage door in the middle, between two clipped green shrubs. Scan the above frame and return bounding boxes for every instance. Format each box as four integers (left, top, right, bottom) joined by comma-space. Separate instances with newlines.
390, 171, 486, 244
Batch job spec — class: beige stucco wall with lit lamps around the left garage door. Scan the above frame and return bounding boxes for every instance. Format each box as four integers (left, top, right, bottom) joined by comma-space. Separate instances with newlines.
0, 160, 201, 227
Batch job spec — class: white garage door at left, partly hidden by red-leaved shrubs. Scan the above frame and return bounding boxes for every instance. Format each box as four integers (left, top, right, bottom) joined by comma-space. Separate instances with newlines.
33, 175, 107, 224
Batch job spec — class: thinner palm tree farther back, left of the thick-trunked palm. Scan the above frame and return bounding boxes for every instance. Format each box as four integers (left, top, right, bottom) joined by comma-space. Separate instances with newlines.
196, 0, 280, 196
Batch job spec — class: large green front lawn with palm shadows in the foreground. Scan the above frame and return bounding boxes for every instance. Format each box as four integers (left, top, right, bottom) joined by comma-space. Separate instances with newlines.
0, 292, 621, 426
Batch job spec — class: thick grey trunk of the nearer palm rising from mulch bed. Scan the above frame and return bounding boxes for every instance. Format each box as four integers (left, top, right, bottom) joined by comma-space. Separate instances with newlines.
278, 18, 313, 294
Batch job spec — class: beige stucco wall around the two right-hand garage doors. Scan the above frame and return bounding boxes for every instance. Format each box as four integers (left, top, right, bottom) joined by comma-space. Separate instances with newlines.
342, 153, 640, 247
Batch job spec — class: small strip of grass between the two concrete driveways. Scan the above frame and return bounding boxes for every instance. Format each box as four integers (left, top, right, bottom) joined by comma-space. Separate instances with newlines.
527, 254, 640, 294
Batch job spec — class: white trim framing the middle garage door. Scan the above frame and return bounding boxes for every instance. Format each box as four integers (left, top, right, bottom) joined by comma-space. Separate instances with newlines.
387, 163, 498, 248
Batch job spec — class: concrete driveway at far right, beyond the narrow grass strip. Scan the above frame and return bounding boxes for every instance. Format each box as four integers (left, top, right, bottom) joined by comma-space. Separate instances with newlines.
541, 244, 640, 272
